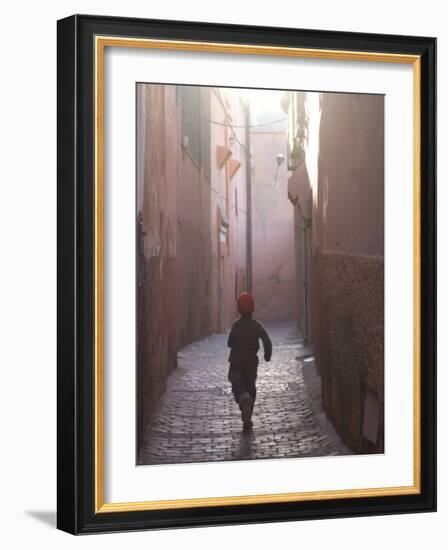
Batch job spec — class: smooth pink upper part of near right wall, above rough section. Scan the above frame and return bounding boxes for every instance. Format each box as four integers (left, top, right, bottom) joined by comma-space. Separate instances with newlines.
314, 93, 384, 255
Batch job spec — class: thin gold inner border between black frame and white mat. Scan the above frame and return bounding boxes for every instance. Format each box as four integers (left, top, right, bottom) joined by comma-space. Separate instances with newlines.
94, 36, 421, 513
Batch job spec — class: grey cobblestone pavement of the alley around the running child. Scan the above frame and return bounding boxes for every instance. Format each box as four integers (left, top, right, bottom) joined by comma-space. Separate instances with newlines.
139, 323, 351, 464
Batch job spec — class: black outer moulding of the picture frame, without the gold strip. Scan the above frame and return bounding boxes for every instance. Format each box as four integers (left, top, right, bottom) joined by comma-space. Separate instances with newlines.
57, 15, 436, 534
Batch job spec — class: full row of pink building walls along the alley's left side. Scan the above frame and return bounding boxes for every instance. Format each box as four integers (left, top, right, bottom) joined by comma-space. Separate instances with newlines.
136, 84, 251, 450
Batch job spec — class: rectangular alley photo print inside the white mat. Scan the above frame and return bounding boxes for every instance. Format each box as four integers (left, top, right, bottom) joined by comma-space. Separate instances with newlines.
136, 82, 385, 466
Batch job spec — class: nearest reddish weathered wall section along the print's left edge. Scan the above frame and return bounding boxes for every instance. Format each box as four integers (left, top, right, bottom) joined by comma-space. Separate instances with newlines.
136, 86, 178, 450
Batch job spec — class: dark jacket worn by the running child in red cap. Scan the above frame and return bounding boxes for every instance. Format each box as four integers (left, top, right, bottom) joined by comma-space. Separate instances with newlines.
227, 314, 272, 363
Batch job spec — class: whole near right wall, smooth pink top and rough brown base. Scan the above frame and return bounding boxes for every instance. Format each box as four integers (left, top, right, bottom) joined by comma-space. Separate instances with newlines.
307, 93, 384, 452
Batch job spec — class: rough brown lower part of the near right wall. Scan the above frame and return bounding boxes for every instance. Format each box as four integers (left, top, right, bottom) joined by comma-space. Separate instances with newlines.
313, 250, 384, 452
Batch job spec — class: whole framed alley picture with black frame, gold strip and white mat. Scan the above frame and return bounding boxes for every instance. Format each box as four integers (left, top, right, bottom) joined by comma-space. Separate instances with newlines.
58, 15, 436, 534
